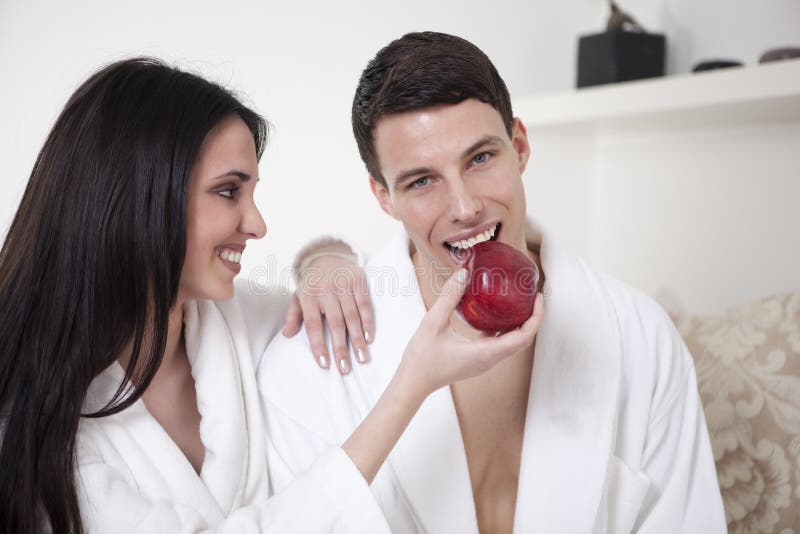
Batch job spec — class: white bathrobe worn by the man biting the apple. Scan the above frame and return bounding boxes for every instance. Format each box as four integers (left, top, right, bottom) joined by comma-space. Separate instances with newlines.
258, 224, 726, 534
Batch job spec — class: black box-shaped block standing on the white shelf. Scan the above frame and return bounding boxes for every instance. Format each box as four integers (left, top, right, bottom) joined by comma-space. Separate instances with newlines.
578, 31, 666, 87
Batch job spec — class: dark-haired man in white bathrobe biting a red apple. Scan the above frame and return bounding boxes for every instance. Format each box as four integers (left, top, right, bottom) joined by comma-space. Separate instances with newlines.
259, 32, 725, 534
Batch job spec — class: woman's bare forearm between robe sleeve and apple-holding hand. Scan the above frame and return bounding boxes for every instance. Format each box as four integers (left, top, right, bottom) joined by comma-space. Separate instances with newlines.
342, 366, 427, 484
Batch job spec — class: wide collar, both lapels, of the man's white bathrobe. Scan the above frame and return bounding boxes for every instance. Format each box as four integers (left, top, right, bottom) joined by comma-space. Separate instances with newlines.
354, 224, 621, 532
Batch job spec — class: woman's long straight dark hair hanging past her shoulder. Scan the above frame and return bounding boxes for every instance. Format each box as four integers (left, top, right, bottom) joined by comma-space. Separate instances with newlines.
0, 58, 267, 534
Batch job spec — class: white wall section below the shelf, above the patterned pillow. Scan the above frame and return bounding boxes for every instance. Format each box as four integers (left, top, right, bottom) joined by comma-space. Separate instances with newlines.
590, 122, 800, 313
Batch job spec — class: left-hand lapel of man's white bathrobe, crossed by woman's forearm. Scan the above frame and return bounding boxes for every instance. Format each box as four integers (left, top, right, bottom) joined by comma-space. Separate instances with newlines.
354, 233, 478, 533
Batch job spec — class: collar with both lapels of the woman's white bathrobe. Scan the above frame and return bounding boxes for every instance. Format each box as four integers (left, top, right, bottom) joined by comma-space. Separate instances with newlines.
85, 301, 268, 524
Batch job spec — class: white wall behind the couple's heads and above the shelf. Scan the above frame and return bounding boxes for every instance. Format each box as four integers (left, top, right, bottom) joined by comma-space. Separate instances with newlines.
0, 0, 800, 308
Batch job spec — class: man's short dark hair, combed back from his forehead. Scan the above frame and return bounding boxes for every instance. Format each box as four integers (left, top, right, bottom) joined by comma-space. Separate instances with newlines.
352, 32, 514, 187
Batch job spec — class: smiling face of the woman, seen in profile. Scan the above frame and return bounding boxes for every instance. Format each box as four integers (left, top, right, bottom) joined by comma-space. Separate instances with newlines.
179, 116, 267, 300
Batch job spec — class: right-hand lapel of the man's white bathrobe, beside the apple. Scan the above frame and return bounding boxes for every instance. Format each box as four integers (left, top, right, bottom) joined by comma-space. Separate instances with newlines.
514, 227, 622, 533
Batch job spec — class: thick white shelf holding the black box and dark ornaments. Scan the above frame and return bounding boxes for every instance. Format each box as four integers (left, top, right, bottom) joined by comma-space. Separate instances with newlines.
514, 60, 800, 131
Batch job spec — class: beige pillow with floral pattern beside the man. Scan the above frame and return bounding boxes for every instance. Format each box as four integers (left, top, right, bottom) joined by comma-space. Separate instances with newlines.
674, 291, 800, 534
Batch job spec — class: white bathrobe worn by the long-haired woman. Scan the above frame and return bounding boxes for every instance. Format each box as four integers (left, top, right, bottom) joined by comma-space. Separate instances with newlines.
77, 286, 386, 534
